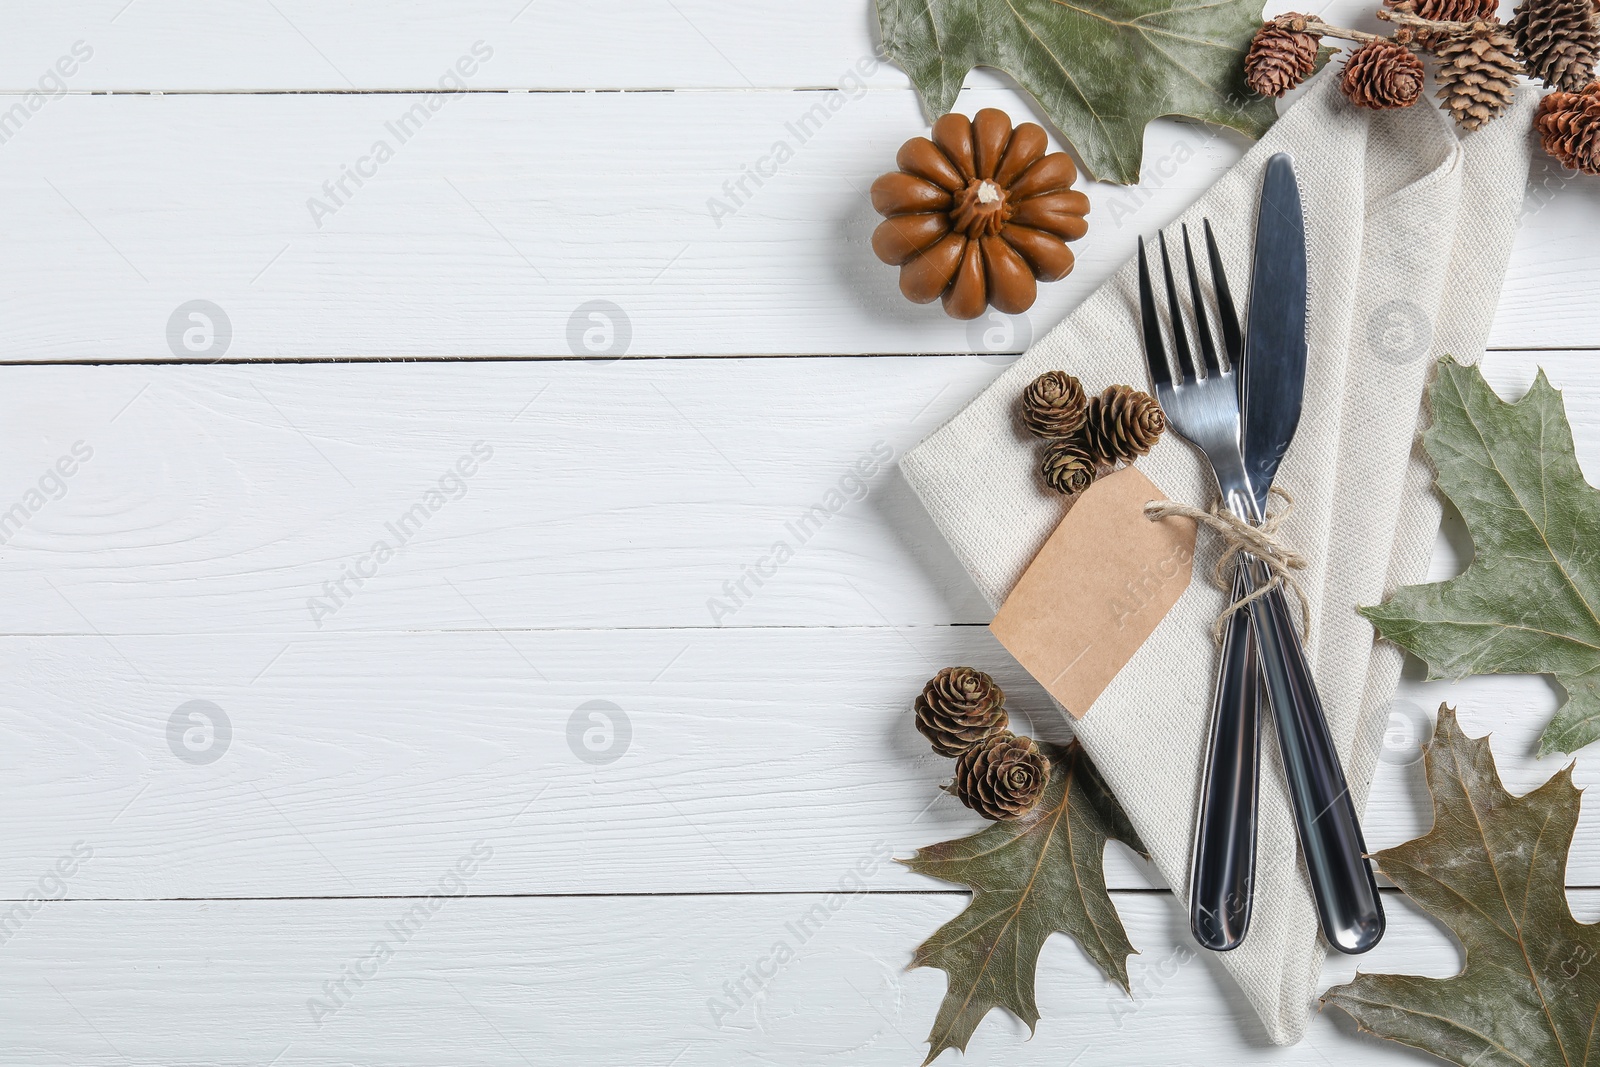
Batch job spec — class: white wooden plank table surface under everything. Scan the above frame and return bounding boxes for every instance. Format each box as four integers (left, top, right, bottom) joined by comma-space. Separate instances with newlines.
0, 0, 1600, 1067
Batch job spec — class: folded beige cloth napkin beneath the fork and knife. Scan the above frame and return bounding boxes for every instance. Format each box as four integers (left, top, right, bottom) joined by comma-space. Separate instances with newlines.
901, 74, 1536, 1045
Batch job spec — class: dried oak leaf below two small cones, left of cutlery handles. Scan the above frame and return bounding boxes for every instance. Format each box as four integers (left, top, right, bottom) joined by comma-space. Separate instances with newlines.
902, 741, 1149, 1064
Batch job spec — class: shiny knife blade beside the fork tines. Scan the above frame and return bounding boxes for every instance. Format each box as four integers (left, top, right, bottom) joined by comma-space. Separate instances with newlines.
1240, 152, 1307, 512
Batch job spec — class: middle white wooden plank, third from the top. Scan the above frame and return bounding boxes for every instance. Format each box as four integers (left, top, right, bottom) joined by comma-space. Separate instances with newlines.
0, 352, 1600, 635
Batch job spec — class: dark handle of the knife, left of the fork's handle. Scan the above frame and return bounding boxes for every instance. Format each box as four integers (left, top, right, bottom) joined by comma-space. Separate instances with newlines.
1189, 566, 1261, 952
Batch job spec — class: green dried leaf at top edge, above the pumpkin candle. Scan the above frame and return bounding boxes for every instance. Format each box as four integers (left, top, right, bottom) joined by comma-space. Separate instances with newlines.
877, 0, 1277, 186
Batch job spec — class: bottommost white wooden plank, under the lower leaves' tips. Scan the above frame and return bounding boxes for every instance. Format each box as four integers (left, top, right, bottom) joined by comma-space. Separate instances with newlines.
0, 889, 1497, 1067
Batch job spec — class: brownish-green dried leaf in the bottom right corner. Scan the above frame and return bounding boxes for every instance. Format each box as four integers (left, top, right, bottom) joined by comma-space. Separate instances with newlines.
1322, 707, 1600, 1067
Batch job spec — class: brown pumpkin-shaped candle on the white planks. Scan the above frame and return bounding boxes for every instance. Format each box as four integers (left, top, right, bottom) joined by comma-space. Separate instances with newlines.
872, 107, 1090, 318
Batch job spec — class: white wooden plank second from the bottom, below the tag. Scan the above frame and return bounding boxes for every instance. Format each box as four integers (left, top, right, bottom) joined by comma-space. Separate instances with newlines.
0, 627, 1600, 897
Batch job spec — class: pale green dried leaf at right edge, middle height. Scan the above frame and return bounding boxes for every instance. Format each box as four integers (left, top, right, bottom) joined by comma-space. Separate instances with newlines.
1362, 358, 1600, 755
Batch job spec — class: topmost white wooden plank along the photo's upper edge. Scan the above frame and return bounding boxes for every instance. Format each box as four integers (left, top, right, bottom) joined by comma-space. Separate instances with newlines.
0, 0, 1366, 93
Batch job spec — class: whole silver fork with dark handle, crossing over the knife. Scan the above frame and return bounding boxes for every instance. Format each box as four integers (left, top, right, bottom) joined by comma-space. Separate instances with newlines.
1139, 229, 1384, 953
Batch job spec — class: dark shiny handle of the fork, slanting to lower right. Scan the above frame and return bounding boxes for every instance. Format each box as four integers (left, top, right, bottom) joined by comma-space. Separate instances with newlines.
1245, 560, 1384, 955
